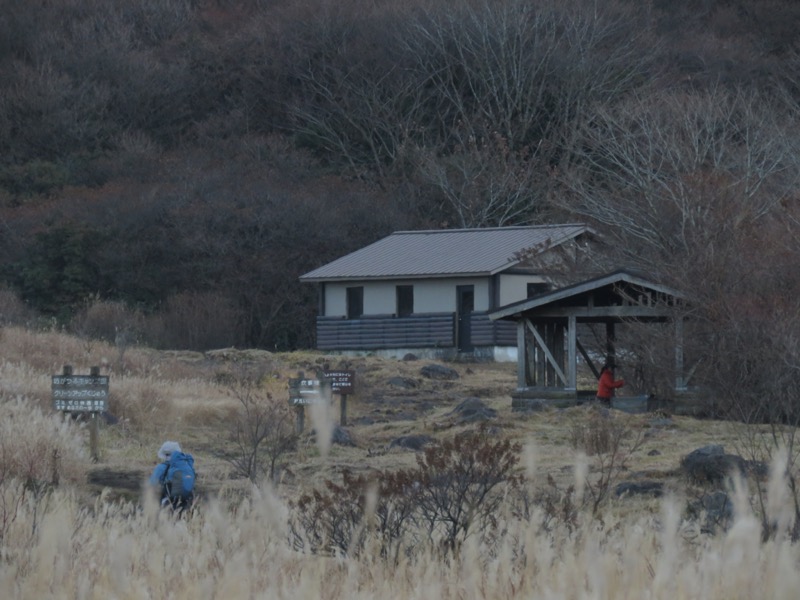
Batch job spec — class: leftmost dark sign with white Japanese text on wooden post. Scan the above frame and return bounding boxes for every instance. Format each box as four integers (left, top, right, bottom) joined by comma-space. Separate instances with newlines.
51, 365, 108, 461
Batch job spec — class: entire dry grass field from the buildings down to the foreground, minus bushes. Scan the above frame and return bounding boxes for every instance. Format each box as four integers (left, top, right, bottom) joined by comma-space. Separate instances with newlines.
0, 327, 800, 600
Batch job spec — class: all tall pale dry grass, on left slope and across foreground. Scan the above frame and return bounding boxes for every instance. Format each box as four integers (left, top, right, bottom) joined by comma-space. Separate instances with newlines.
0, 328, 800, 600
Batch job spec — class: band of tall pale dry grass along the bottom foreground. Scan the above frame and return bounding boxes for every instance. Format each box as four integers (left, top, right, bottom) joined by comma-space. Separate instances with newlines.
0, 468, 800, 600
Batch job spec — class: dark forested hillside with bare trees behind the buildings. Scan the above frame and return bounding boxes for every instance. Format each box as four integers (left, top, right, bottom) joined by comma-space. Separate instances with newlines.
0, 0, 800, 408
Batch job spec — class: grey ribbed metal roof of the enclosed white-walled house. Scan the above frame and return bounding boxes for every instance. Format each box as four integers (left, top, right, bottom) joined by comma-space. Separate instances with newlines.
300, 224, 590, 282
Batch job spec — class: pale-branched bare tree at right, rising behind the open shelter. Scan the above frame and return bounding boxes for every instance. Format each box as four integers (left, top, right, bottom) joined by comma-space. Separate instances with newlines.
560, 87, 800, 418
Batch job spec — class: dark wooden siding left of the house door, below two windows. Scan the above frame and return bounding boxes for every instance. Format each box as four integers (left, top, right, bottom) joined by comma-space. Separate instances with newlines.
317, 313, 454, 350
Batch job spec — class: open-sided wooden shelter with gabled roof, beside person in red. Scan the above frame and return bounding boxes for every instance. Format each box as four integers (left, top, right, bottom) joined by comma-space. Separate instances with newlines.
489, 269, 687, 401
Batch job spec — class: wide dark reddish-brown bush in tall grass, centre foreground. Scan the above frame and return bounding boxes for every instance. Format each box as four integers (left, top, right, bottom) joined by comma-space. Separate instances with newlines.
293, 428, 521, 555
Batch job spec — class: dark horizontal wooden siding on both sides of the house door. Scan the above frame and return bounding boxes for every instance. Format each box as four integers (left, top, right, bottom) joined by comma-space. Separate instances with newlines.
317, 313, 517, 350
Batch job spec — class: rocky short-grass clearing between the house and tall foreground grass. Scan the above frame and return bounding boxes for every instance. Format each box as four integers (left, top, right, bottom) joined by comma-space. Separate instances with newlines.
79, 351, 737, 516
